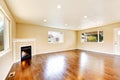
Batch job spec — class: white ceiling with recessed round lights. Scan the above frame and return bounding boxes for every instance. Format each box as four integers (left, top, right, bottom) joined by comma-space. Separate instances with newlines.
6, 0, 120, 30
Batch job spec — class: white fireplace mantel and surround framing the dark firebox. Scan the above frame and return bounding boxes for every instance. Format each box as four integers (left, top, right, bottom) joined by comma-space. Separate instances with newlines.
13, 38, 36, 62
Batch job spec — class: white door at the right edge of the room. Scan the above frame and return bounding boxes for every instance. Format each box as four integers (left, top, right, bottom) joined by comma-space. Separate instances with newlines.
114, 28, 120, 55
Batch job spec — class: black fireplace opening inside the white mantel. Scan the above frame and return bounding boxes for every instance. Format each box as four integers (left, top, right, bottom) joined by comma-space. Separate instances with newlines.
21, 46, 32, 61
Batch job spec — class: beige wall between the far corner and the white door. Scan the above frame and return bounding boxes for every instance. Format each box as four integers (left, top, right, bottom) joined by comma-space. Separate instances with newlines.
77, 23, 120, 54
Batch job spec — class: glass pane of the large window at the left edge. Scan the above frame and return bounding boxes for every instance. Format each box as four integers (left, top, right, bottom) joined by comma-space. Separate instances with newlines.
0, 11, 4, 51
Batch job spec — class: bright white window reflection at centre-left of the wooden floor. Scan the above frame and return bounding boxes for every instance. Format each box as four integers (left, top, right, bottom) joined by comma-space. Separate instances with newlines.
44, 56, 66, 80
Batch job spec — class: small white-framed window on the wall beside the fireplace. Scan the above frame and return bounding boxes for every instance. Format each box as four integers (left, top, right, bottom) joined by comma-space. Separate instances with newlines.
48, 31, 63, 43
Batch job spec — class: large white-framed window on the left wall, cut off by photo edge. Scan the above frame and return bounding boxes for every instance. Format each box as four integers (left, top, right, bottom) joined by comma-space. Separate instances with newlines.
0, 10, 10, 53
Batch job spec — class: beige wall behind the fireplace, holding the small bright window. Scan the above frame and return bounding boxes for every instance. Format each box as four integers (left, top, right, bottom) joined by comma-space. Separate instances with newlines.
16, 24, 76, 54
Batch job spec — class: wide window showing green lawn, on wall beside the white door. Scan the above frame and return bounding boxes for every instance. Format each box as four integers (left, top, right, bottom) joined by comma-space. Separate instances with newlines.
81, 31, 103, 42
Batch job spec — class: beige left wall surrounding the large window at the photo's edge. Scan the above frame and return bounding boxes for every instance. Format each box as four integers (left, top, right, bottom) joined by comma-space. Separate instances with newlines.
0, 0, 16, 80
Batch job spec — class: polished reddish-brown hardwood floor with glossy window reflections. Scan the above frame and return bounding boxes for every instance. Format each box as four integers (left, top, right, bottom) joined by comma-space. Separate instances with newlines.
6, 50, 120, 80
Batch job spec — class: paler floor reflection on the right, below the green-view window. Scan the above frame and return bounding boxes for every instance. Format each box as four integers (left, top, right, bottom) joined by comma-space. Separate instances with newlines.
79, 52, 104, 80
